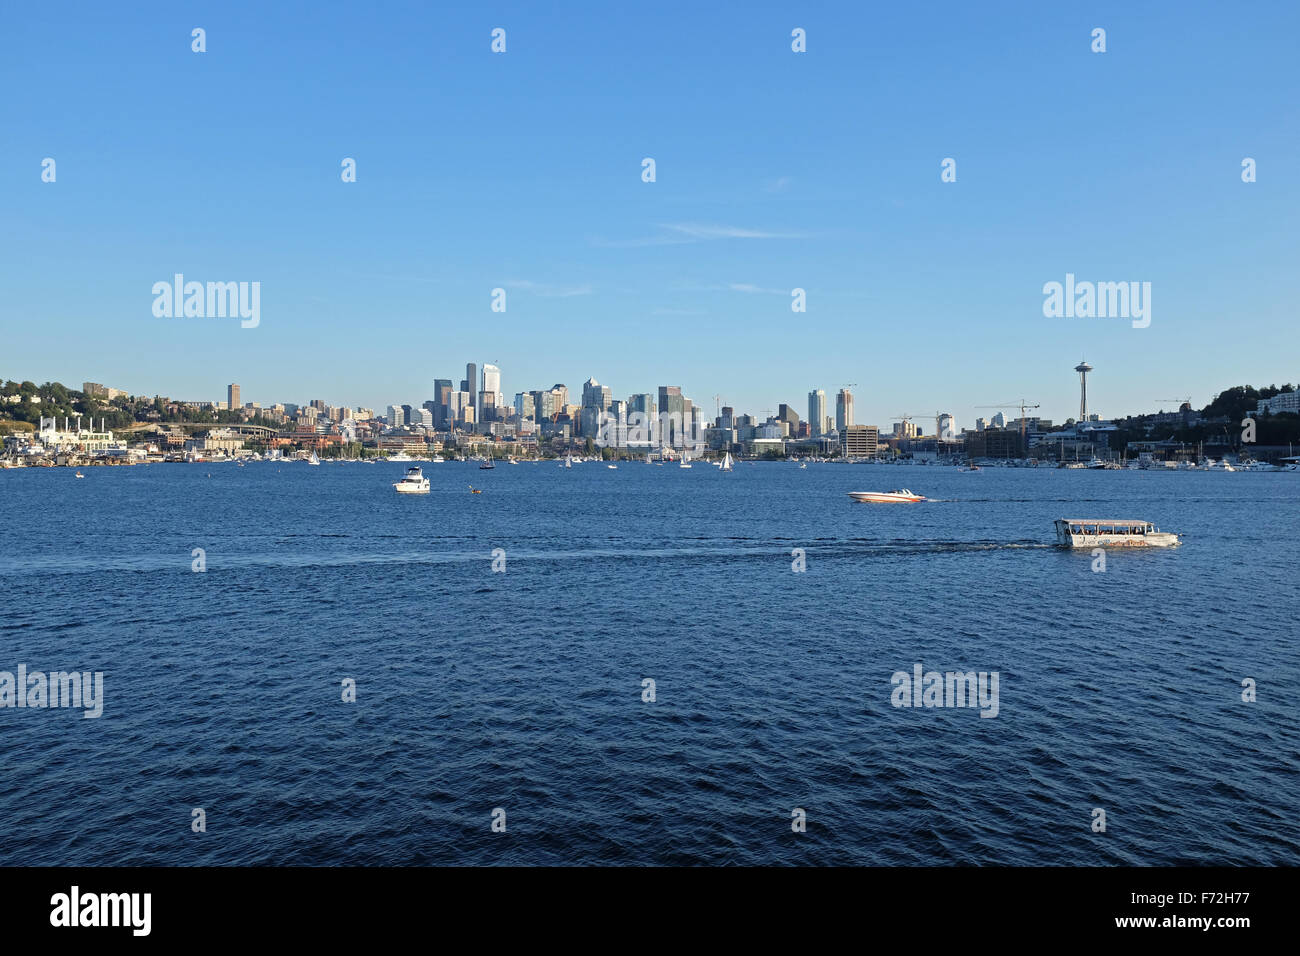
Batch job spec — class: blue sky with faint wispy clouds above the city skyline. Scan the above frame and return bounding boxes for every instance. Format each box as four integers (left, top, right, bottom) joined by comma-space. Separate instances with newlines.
0, 0, 1300, 427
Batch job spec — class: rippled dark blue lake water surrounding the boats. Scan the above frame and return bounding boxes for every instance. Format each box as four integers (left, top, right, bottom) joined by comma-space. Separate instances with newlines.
0, 462, 1300, 865
